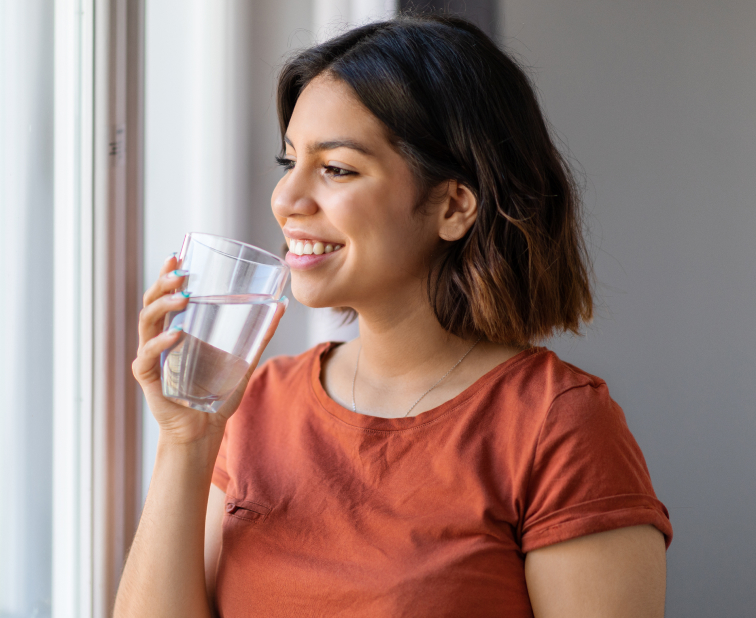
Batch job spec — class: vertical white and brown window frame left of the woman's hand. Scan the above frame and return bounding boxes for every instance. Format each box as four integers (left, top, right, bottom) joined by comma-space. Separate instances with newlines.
52, 0, 144, 618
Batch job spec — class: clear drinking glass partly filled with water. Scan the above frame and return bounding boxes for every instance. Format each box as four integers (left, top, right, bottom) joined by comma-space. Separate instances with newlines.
160, 232, 289, 412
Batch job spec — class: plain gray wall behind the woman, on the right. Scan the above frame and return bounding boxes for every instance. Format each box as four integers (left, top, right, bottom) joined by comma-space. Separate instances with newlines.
499, 0, 756, 618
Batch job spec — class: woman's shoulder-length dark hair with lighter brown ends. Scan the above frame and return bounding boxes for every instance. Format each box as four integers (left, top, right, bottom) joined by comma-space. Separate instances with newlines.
278, 15, 593, 345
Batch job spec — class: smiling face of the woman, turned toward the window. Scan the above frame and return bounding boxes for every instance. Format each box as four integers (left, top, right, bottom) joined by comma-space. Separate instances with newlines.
271, 77, 442, 311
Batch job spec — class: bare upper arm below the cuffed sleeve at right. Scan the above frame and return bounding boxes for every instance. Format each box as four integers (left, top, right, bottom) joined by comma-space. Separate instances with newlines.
525, 526, 666, 618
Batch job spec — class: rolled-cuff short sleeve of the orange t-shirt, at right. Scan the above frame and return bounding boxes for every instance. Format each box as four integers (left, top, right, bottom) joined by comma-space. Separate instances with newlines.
521, 382, 672, 552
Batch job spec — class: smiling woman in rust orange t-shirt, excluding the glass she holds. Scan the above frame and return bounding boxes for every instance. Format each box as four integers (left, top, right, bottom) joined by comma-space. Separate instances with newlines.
116, 16, 672, 618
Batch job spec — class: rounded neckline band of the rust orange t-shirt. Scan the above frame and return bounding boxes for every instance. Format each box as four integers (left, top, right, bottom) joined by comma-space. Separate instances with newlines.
310, 341, 546, 432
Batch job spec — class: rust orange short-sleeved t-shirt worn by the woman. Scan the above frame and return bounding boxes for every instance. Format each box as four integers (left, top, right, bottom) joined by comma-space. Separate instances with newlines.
213, 344, 672, 618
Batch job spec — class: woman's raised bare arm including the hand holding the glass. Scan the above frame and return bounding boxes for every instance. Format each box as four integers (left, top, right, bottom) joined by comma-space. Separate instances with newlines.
113, 257, 285, 618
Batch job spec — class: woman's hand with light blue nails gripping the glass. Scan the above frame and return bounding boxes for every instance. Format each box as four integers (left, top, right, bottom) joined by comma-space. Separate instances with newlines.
131, 256, 285, 444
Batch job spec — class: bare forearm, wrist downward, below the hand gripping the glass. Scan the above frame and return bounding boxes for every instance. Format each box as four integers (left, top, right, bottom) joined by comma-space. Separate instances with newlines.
114, 433, 222, 618
